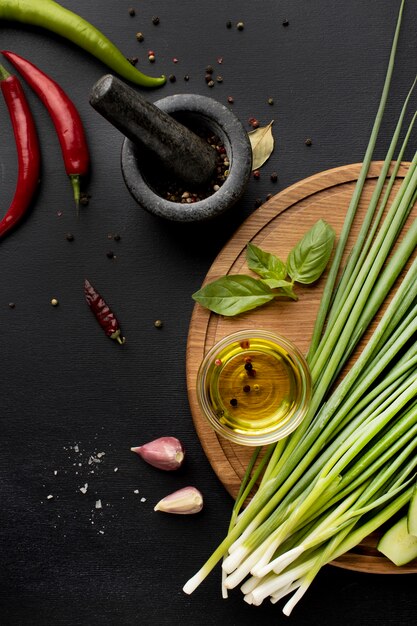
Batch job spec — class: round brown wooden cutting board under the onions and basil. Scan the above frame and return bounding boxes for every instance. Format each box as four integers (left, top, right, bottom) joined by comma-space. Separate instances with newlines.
187, 163, 417, 573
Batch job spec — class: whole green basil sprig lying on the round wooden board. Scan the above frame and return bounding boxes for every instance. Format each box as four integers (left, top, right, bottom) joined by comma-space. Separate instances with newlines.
192, 220, 335, 316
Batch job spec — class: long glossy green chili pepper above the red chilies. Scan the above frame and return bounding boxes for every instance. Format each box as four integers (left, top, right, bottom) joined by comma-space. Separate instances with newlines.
0, 0, 166, 87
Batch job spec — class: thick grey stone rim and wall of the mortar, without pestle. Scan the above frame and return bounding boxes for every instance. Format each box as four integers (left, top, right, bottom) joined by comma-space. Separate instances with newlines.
121, 94, 252, 222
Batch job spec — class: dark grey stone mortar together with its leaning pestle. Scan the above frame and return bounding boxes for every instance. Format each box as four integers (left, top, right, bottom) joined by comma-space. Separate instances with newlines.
90, 74, 252, 222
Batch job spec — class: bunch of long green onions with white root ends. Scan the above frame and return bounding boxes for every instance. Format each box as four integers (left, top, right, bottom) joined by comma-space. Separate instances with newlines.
184, 0, 417, 615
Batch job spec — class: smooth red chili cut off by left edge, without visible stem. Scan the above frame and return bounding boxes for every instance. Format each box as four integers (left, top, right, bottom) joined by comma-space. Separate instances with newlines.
0, 65, 41, 237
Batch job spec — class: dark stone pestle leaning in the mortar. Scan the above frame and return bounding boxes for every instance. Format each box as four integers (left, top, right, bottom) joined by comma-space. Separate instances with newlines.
90, 74, 216, 187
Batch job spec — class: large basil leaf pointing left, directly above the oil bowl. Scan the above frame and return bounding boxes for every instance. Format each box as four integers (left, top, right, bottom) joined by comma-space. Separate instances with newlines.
192, 274, 275, 316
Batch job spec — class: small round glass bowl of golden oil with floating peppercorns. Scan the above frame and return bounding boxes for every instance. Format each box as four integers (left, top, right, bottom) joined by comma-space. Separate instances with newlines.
197, 330, 311, 446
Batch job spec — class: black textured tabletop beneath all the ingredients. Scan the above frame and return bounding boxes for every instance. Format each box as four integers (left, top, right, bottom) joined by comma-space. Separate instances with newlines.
0, 0, 417, 626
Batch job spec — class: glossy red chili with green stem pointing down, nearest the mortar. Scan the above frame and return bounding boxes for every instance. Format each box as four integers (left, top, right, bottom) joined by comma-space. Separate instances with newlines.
2, 50, 90, 207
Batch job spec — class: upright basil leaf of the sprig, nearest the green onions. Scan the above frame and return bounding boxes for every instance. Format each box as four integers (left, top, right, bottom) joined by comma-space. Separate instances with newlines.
287, 220, 336, 285
